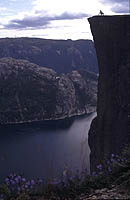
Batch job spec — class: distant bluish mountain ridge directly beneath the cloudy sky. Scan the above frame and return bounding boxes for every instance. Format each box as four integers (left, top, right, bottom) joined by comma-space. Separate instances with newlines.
0, 38, 98, 73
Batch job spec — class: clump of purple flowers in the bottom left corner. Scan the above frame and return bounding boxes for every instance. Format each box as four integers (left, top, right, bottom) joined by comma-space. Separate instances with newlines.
0, 173, 43, 200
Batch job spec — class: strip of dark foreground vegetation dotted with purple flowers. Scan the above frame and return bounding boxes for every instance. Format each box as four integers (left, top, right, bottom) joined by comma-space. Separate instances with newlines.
0, 146, 130, 200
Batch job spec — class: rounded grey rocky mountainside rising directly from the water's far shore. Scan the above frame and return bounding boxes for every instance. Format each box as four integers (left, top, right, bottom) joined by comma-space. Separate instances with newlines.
0, 58, 97, 124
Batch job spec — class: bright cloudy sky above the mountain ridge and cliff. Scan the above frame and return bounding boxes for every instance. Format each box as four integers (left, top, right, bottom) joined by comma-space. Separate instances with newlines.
0, 0, 130, 40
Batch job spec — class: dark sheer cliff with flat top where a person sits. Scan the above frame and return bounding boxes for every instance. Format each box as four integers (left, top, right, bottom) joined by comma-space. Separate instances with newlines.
89, 15, 130, 170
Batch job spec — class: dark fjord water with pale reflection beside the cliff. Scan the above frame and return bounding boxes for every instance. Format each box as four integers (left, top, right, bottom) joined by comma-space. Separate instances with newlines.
0, 113, 96, 179
